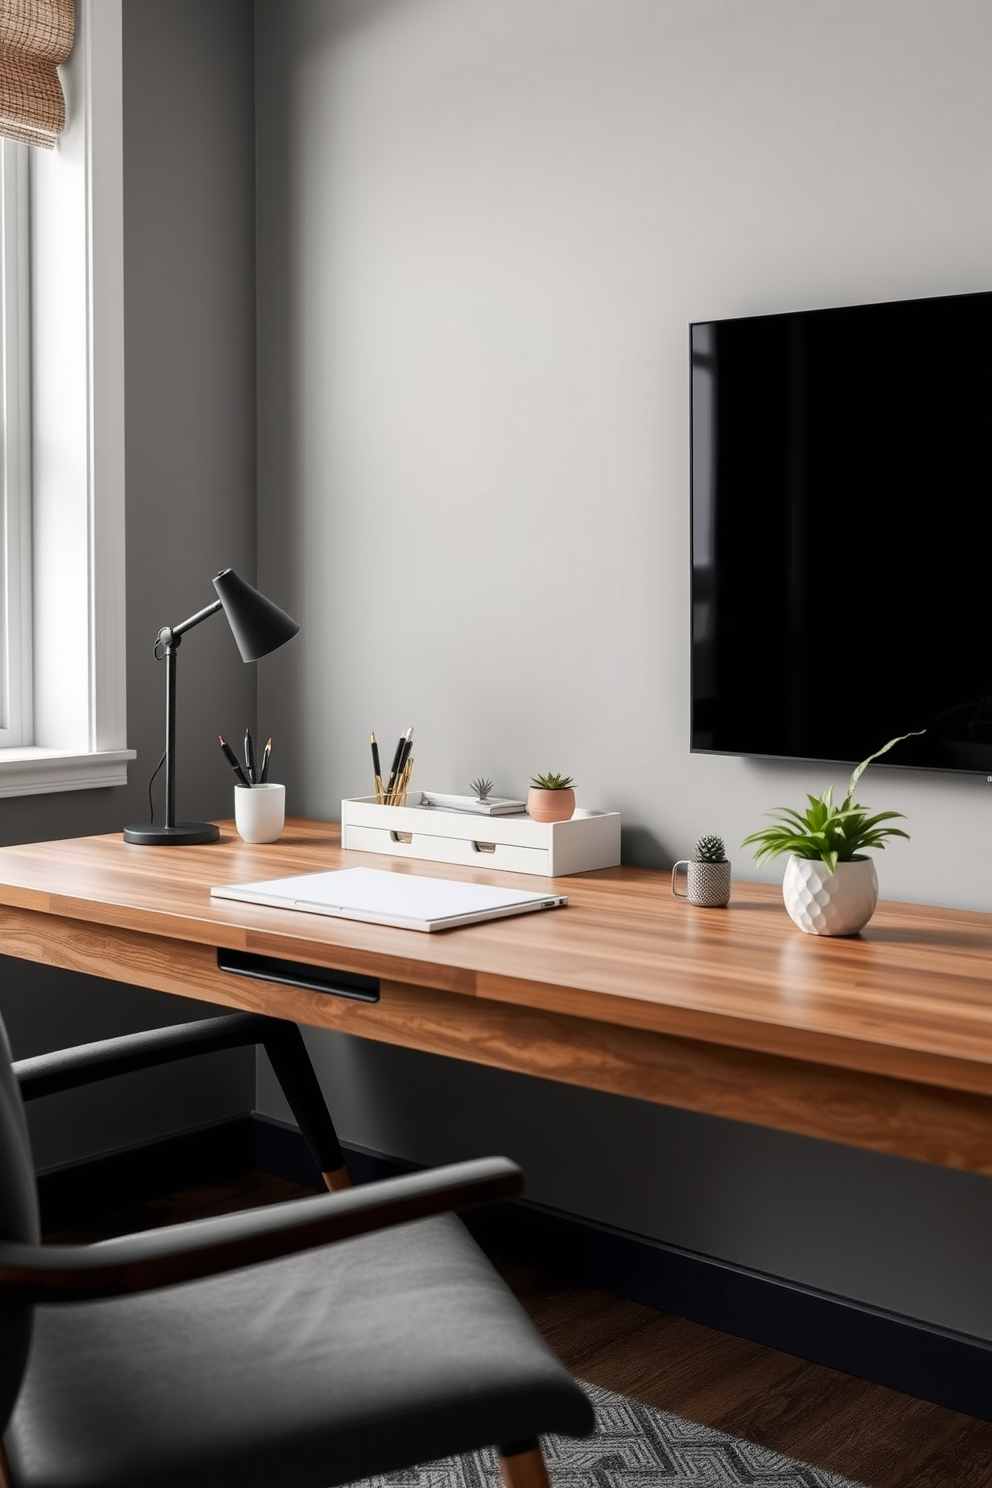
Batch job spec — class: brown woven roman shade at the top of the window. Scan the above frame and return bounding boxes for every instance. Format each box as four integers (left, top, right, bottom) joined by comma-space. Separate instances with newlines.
0, 0, 76, 150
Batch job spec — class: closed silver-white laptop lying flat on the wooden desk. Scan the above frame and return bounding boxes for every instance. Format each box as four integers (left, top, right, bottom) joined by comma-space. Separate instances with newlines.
210, 868, 568, 930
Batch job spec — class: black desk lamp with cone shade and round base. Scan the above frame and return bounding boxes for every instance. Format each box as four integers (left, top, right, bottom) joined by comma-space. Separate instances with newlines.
123, 568, 299, 847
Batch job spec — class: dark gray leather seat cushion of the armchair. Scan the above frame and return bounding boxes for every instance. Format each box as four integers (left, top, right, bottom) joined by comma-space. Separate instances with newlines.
6, 1216, 592, 1488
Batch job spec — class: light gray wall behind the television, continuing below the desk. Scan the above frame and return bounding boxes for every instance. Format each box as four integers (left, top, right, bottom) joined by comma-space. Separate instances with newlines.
256, 0, 992, 1336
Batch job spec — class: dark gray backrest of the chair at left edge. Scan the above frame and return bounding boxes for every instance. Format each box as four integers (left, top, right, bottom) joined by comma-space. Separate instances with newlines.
0, 1019, 40, 1431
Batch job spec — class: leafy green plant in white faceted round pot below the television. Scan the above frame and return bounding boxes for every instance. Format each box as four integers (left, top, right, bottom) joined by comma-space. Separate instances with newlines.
744, 729, 924, 934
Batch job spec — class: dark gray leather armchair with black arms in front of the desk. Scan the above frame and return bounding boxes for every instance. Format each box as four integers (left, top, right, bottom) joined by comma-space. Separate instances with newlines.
0, 1015, 592, 1488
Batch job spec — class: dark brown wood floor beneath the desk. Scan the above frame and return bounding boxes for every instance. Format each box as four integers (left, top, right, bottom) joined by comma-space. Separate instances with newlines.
46, 1173, 992, 1488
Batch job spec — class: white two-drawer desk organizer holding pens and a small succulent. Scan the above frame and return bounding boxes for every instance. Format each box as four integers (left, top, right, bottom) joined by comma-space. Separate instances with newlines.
341, 790, 620, 878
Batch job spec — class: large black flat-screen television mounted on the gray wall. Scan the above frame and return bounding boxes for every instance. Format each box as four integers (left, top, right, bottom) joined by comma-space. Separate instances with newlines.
690, 293, 992, 775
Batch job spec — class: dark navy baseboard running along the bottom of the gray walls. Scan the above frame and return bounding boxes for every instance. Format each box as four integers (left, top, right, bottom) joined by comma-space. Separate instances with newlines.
39, 1113, 992, 1421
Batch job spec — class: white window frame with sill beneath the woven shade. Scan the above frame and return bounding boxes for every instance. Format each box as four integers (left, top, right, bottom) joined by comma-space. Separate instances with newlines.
0, 0, 134, 796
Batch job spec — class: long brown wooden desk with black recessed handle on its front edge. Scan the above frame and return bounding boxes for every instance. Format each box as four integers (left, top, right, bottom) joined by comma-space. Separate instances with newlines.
0, 821, 992, 1173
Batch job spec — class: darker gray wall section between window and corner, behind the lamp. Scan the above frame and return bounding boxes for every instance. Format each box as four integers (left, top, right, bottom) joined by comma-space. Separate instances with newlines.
0, 0, 256, 1167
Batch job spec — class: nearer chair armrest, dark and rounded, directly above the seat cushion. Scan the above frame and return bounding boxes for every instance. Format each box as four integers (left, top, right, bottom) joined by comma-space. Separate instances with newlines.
0, 1158, 524, 1303
